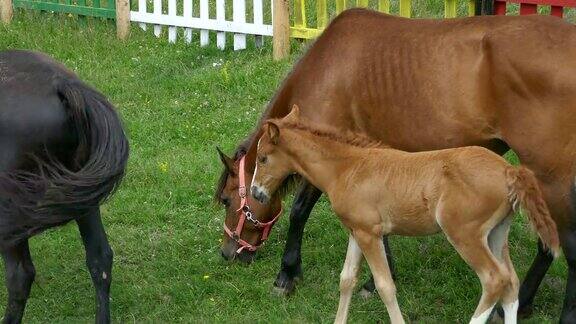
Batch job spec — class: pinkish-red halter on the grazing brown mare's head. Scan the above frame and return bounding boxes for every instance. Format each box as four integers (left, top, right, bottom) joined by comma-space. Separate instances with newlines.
224, 156, 282, 253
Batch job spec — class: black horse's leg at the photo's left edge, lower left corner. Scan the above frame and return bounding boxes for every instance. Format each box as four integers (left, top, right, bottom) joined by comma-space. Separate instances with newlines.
2, 240, 36, 323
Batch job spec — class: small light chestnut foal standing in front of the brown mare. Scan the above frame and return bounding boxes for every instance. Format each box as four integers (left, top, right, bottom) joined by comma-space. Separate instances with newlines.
251, 106, 559, 323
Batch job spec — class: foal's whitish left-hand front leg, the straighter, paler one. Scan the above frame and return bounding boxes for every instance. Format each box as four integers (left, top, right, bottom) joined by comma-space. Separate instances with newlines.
334, 234, 362, 323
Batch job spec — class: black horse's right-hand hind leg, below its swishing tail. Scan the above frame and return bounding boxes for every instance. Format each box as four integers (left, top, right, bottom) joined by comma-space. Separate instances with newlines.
76, 208, 113, 323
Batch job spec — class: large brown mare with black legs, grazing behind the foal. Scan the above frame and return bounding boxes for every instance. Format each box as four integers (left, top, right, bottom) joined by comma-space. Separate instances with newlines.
216, 9, 576, 322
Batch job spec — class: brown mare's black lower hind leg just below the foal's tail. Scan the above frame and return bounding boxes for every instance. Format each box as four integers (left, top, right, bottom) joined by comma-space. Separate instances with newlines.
518, 240, 554, 317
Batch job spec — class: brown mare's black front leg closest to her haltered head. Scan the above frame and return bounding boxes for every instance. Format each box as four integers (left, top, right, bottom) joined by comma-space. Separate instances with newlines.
274, 180, 322, 294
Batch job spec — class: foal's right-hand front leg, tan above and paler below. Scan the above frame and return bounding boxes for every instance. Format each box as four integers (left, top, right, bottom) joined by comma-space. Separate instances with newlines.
354, 231, 404, 324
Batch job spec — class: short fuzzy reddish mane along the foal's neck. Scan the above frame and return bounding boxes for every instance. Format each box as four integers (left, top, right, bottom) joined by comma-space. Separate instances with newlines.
279, 120, 390, 148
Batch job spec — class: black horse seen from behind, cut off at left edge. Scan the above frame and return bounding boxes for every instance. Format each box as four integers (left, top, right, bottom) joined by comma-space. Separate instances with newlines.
0, 51, 128, 323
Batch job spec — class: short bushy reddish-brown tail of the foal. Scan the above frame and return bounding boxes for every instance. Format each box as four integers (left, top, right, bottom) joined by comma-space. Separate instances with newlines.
506, 166, 560, 257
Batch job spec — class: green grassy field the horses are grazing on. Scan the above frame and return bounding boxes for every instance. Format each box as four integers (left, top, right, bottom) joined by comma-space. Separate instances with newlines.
0, 1, 566, 323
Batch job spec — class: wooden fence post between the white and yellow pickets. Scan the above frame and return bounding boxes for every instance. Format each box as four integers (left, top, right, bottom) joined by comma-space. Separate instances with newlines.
272, 0, 290, 61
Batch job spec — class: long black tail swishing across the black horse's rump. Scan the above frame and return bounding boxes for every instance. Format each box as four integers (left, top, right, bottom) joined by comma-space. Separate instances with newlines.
0, 78, 129, 249
